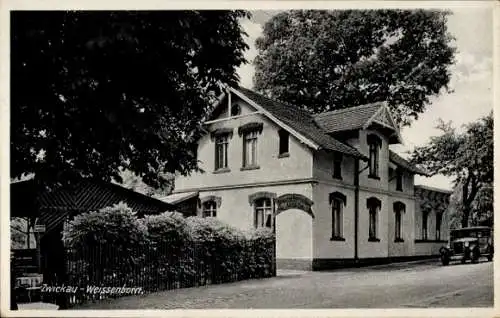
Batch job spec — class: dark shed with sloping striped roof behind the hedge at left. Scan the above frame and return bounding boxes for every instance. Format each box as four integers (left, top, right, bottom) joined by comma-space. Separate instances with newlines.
10, 179, 175, 281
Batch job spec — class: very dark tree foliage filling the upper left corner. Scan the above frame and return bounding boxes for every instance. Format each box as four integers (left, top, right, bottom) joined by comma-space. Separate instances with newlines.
11, 11, 249, 187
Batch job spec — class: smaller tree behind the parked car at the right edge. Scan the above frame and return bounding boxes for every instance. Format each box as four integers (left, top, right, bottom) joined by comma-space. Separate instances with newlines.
411, 113, 493, 227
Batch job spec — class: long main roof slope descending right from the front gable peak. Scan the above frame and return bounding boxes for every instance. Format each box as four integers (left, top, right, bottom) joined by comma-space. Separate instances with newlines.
230, 87, 366, 159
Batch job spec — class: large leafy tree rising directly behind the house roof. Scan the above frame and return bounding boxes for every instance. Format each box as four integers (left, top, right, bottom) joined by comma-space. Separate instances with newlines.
254, 10, 455, 125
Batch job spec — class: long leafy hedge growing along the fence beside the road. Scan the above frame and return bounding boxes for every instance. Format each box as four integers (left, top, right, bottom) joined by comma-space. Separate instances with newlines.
43, 205, 276, 307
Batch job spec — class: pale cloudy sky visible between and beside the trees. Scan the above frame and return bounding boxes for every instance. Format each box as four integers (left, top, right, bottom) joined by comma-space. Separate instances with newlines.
238, 7, 493, 189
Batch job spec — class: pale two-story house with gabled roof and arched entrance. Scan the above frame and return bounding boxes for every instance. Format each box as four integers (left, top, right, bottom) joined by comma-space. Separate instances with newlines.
167, 88, 449, 269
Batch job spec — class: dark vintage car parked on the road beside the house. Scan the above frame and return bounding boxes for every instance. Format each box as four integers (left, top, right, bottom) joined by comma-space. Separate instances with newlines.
439, 226, 493, 265
